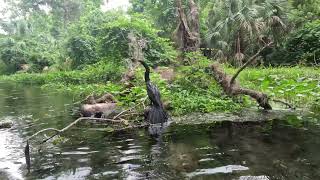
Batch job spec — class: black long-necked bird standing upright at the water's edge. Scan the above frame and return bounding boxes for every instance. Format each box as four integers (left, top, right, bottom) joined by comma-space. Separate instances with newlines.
140, 61, 168, 124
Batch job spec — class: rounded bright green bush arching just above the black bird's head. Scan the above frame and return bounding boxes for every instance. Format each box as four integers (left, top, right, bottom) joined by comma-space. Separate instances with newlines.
99, 15, 176, 64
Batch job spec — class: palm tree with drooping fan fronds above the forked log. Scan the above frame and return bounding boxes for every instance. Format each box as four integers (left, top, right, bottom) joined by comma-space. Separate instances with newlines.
206, 0, 286, 65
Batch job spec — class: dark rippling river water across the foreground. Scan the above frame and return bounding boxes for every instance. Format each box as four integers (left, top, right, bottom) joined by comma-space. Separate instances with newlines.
0, 83, 320, 180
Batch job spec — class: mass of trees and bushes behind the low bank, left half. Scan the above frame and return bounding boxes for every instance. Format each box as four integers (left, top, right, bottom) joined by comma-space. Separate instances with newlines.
0, 0, 176, 73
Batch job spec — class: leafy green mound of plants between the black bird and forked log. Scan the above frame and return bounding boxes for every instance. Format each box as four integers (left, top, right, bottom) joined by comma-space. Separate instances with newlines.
168, 53, 240, 115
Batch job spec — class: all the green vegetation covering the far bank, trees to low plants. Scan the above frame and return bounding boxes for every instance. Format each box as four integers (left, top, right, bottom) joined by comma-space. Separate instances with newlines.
0, 0, 320, 115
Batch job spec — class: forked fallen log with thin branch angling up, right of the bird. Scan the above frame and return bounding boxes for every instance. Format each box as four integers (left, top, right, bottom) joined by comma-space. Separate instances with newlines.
211, 43, 272, 110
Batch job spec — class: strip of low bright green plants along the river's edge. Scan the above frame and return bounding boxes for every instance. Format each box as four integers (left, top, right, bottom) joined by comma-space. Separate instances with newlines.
0, 61, 320, 115
